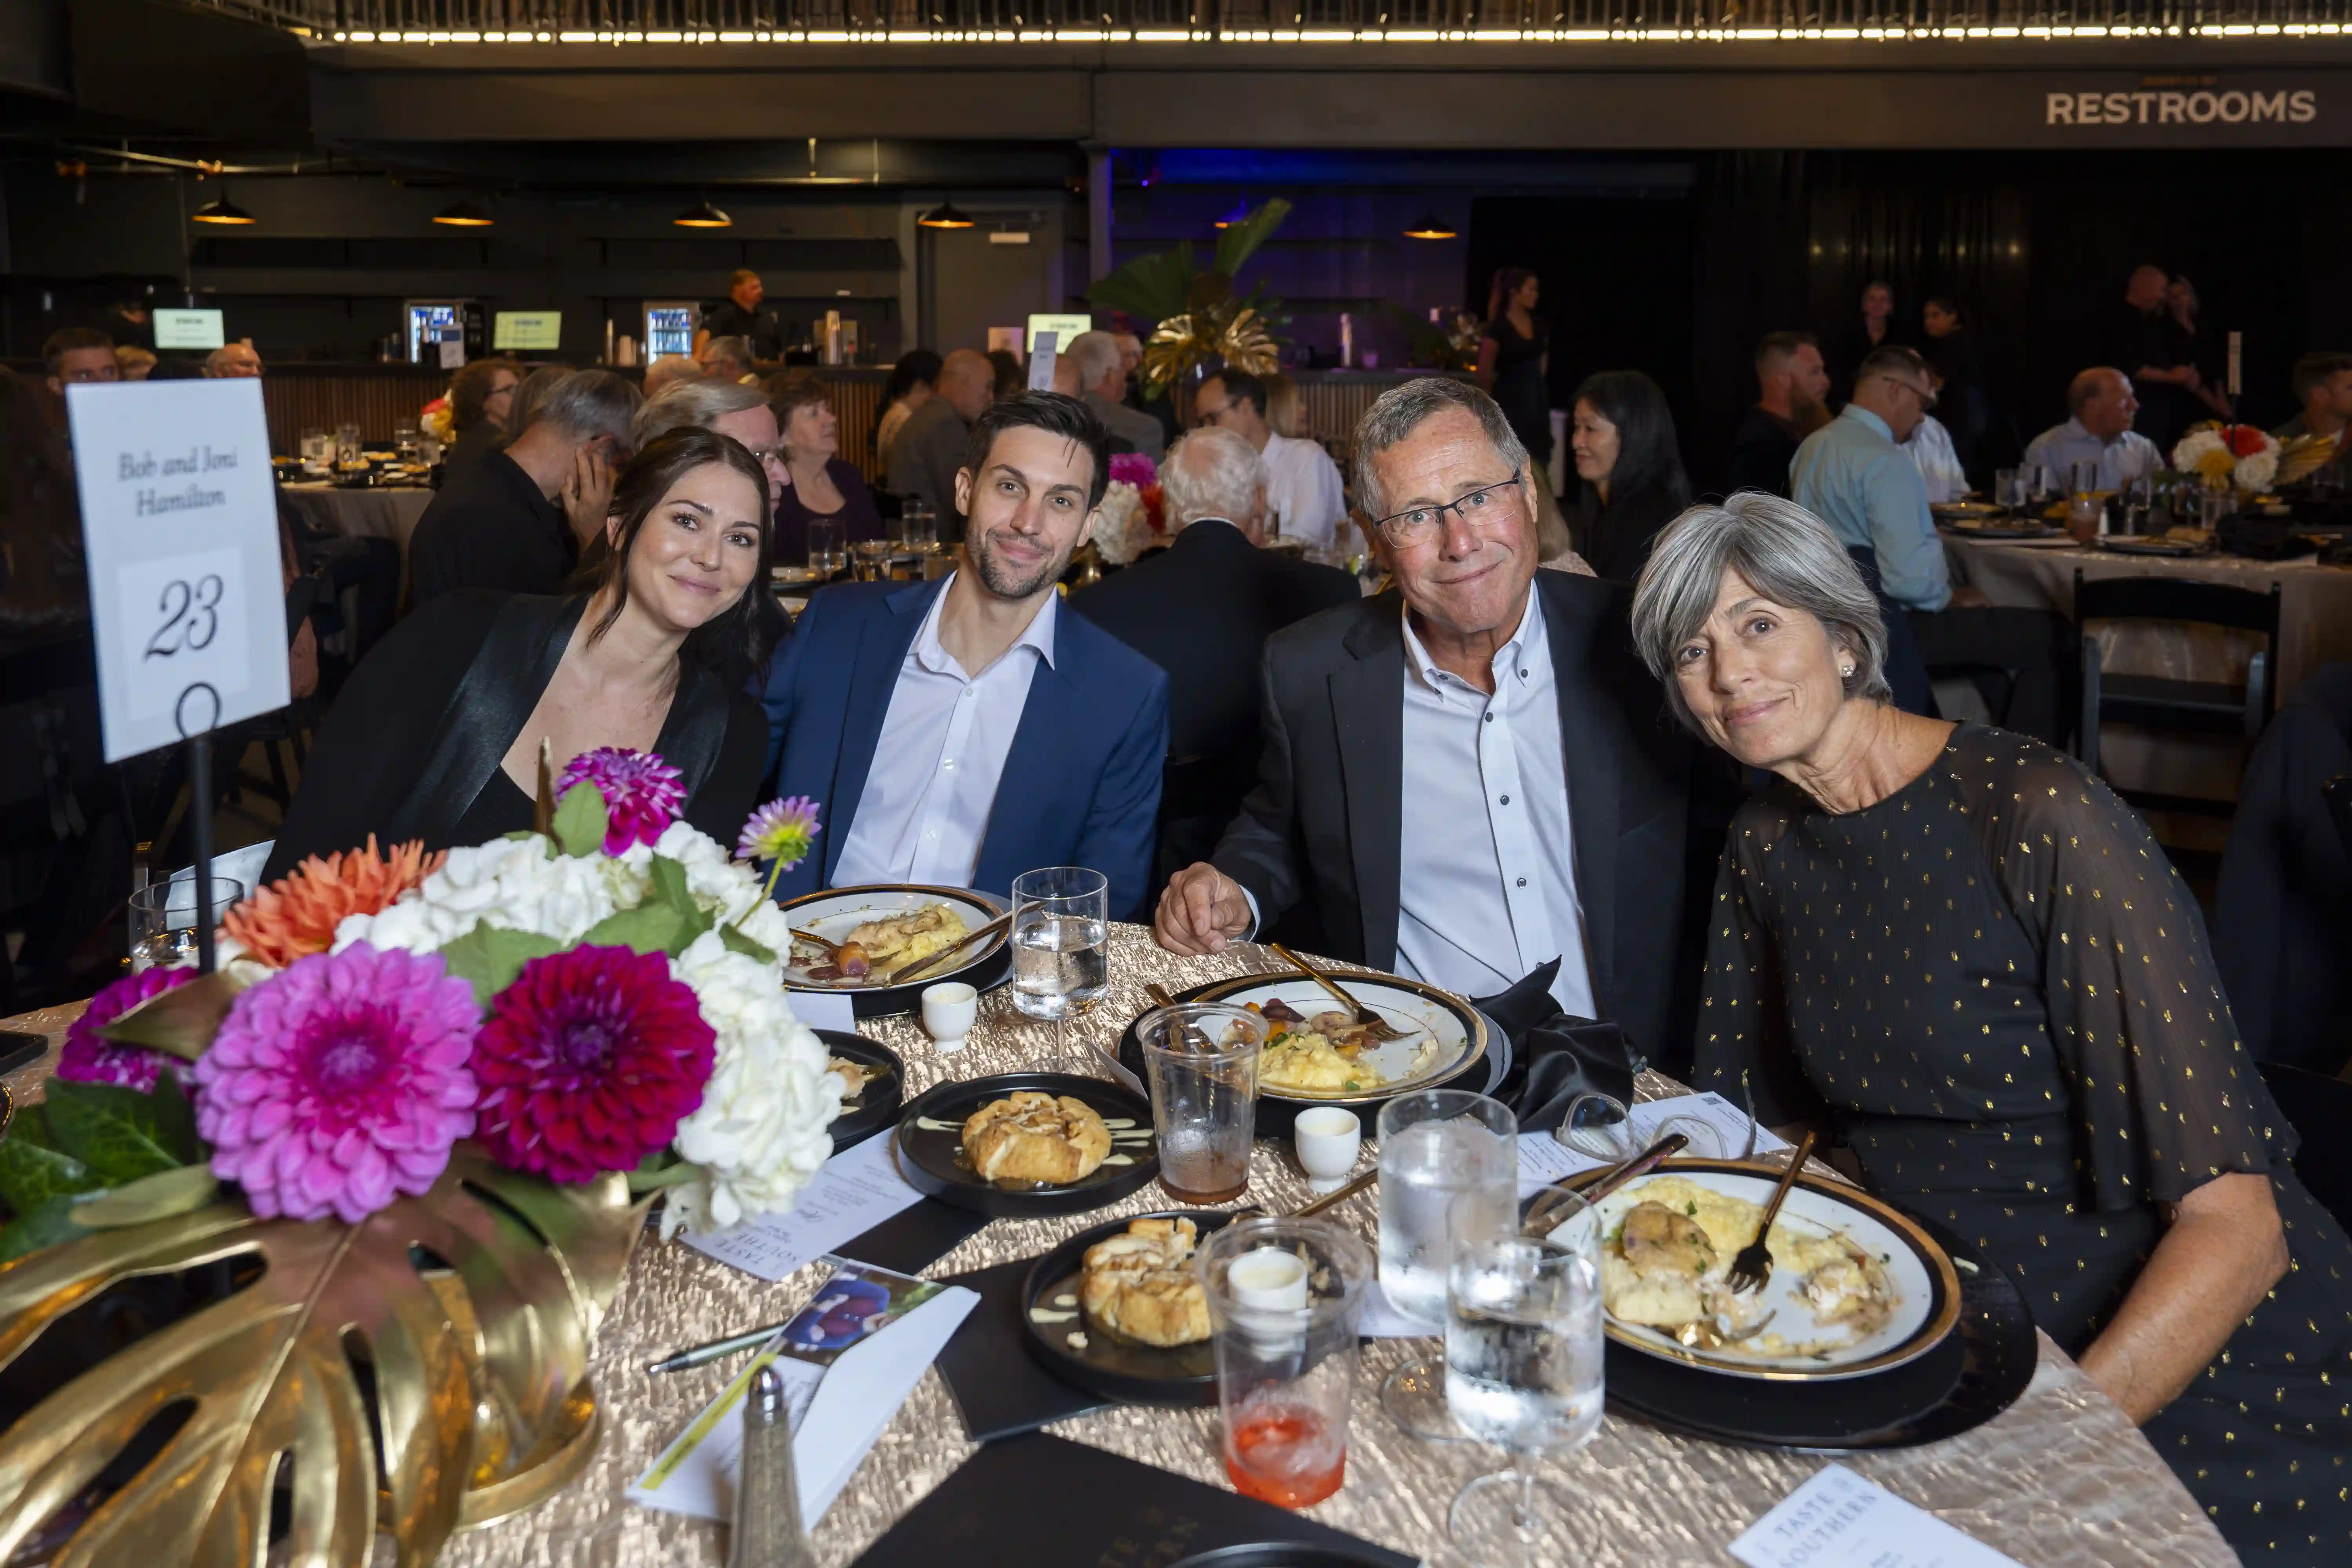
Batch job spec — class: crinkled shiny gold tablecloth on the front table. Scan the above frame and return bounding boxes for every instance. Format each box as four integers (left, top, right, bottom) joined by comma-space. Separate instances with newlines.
12, 926, 2237, 1568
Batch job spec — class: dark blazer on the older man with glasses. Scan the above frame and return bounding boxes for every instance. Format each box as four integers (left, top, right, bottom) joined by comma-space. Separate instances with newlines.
1211, 571, 1731, 1065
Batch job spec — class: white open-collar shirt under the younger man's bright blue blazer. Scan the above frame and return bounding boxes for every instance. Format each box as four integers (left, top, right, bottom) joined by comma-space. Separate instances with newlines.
833, 573, 1061, 886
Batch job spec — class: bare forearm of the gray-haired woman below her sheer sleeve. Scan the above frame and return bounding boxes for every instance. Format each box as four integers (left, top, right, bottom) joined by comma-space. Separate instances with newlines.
2082, 1171, 2286, 1425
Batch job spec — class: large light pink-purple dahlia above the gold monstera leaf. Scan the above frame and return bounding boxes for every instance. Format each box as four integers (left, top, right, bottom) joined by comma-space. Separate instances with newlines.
193, 943, 482, 1225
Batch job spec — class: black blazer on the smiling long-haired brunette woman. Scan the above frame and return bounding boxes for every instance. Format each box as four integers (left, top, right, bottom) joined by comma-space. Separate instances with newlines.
263, 592, 767, 879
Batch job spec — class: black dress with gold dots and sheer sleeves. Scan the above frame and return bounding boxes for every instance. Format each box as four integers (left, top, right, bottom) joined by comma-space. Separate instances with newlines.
1696, 724, 2352, 1566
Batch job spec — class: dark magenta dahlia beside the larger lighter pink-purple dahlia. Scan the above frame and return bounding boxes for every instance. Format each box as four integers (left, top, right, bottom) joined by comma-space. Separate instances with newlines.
473, 947, 717, 1182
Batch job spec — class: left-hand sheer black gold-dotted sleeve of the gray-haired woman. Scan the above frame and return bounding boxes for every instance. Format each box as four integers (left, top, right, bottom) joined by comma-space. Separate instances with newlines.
1691, 802, 1823, 1126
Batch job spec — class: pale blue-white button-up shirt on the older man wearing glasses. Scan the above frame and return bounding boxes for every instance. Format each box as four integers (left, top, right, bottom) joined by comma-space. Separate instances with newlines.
1397, 592, 1597, 1018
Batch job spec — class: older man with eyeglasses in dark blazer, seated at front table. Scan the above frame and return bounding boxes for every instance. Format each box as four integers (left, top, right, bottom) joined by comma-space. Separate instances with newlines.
1152, 379, 1722, 1063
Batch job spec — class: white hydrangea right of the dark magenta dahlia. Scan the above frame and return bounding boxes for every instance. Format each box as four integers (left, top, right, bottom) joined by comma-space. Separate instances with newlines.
661, 931, 842, 1239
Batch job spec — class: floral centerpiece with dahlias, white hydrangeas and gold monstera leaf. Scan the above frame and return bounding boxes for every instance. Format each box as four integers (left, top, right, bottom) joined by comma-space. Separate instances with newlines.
0, 750, 842, 1563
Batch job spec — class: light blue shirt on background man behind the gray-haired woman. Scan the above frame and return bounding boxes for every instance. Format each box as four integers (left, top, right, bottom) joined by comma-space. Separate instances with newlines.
1788, 402, 1952, 611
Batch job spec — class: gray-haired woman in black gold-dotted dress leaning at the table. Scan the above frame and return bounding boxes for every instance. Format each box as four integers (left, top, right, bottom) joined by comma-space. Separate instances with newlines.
1632, 491, 2352, 1563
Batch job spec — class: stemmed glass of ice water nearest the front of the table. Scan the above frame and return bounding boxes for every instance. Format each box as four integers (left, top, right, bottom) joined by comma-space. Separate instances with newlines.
1446, 1194, 1604, 1568
